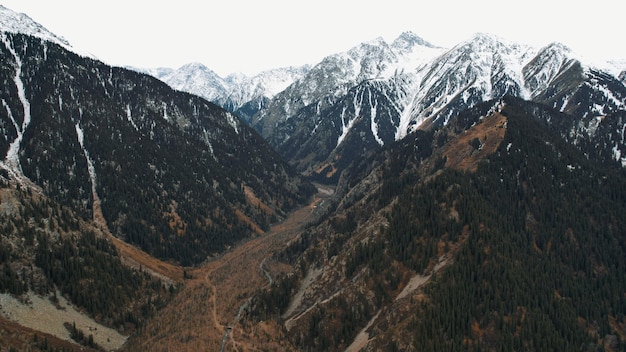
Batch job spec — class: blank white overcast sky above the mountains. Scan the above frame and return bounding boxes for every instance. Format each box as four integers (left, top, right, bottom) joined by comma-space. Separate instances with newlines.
0, 0, 626, 76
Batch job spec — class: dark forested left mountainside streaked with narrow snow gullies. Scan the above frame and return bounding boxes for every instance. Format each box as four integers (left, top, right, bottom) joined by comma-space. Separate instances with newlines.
0, 32, 313, 264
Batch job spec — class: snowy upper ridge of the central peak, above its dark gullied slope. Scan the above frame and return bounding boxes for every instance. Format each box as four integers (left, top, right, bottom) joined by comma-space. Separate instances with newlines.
252, 32, 445, 141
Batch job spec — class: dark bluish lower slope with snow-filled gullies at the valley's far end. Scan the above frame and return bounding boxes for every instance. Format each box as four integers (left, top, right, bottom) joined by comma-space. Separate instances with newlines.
276, 75, 412, 183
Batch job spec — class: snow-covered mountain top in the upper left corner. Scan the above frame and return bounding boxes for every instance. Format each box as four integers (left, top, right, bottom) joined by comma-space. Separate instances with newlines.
0, 5, 76, 52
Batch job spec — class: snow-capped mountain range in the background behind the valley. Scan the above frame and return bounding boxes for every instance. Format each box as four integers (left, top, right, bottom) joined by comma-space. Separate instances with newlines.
141, 32, 626, 183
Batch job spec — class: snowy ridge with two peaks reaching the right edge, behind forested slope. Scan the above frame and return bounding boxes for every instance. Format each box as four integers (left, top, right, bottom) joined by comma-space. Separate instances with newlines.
396, 33, 626, 140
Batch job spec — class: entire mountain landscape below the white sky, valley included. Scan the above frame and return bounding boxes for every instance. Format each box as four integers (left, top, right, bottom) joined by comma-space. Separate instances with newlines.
0, 6, 626, 351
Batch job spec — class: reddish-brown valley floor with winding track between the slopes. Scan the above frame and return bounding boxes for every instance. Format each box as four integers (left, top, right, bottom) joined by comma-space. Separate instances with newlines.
119, 186, 333, 351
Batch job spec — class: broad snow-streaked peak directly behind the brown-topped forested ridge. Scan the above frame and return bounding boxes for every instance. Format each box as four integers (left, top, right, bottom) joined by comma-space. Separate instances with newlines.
396, 33, 535, 140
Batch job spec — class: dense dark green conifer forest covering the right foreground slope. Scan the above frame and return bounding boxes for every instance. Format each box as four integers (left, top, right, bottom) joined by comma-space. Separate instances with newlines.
388, 108, 626, 351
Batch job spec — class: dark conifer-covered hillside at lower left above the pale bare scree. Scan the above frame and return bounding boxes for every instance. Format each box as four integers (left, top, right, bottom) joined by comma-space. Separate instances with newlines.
0, 175, 178, 347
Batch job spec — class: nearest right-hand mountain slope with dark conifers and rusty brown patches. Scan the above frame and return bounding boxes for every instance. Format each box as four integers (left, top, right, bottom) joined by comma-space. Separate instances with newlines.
242, 98, 626, 351
